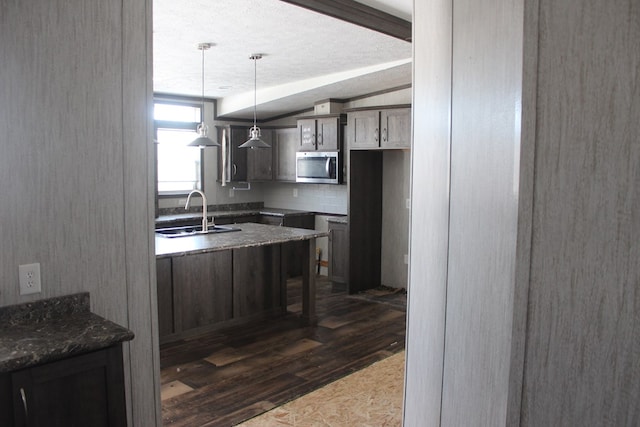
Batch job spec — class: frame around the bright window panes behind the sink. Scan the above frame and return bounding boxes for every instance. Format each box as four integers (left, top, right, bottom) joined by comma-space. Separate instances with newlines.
153, 98, 205, 200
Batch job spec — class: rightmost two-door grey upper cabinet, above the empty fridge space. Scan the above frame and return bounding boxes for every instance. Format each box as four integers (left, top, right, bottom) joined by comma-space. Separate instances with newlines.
347, 106, 411, 150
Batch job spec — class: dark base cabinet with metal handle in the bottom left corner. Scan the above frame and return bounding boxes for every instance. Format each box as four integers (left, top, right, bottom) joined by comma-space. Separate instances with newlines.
0, 344, 127, 427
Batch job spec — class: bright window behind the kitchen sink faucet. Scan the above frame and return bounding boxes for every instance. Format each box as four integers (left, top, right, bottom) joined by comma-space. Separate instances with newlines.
153, 102, 203, 196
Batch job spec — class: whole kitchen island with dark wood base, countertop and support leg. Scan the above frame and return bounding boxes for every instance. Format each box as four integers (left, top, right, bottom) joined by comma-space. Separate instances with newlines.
155, 223, 328, 342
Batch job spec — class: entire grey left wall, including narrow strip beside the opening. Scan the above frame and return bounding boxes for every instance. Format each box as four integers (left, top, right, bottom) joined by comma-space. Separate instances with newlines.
0, 0, 160, 426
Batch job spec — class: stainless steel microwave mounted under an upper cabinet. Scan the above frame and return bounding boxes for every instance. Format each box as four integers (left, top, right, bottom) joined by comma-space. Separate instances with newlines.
296, 151, 342, 184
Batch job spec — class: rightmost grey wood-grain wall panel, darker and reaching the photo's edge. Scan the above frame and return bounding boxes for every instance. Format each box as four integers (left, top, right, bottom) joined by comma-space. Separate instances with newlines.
523, 0, 640, 426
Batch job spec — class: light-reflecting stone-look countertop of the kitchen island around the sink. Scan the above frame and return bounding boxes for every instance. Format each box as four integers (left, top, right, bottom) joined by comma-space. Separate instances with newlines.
156, 222, 329, 258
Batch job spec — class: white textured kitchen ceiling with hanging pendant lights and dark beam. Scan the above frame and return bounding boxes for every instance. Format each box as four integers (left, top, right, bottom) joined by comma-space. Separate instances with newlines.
153, 0, 413, 119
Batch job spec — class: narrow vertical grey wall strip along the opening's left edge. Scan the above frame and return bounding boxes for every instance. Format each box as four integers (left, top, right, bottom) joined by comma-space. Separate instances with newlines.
121, 0, 162, 425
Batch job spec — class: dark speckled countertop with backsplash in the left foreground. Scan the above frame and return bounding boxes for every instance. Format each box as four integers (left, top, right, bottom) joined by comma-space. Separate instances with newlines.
0, 292, 133, 373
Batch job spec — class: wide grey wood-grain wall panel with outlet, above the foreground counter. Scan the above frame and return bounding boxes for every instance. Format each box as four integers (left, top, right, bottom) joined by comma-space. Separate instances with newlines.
0, 0, 126, 323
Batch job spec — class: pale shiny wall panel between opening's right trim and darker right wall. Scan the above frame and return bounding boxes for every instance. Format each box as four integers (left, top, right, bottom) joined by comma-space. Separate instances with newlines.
442, 1, 523, 426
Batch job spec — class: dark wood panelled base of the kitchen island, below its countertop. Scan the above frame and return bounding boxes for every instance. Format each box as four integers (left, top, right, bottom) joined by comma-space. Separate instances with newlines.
156, 245, 286, 343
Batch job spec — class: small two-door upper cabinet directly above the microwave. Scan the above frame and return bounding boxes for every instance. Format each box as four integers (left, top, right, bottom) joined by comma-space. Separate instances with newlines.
298, 114, 345, 151
